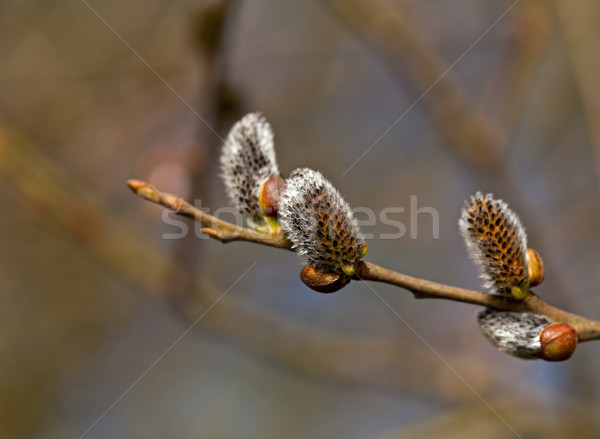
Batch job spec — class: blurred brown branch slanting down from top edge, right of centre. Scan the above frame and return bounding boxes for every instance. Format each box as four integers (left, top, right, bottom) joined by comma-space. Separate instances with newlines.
322, 0, 500, 169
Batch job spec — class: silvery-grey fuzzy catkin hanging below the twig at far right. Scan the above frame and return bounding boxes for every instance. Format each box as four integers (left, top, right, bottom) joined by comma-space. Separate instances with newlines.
477, 308, 552, 359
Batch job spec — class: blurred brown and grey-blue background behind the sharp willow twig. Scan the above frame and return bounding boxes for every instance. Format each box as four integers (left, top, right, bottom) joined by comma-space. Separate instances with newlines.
0, 0, 600, 439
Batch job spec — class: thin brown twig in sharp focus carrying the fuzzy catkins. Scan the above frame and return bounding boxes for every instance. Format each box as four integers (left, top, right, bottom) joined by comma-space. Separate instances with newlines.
127, 180, 600, 341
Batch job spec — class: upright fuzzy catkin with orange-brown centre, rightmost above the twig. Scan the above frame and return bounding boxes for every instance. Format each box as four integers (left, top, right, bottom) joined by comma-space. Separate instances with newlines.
459, 192, 530, 300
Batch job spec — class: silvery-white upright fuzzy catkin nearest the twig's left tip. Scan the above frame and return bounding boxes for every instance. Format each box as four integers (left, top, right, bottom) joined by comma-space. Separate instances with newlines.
221, 113, 281, 232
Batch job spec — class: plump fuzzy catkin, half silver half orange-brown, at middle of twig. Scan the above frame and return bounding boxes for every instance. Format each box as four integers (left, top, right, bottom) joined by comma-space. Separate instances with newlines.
279, 168, 367, 277
